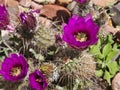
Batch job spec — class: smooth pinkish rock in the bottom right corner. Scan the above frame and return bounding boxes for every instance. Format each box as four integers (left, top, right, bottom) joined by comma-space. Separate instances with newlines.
112, 73, 120, 90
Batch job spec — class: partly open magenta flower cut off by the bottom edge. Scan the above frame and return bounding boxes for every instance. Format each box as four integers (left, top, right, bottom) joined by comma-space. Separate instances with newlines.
29, 70, 48, 90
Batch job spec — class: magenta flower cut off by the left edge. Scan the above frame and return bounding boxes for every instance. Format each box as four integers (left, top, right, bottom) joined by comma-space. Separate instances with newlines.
0, 5, 10, 29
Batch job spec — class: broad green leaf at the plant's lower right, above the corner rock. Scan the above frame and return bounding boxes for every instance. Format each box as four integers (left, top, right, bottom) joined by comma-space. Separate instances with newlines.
107, 61, 119, 75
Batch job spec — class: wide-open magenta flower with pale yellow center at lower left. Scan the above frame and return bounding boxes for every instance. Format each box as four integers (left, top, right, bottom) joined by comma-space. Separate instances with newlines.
0, 54, 28, 82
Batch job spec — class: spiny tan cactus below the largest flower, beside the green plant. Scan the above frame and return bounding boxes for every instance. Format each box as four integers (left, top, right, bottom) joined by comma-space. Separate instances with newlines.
58, 53, 96, 90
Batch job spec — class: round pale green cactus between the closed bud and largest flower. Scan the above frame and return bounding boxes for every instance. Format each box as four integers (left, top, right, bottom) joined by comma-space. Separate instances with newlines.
35, 28, 55, 48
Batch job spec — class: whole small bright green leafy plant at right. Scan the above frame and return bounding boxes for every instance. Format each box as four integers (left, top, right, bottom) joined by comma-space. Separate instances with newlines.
90, 35, 119, 85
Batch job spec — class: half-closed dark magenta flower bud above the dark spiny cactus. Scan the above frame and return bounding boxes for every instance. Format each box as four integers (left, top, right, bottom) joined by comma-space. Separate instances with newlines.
20, 12, 37, 30
